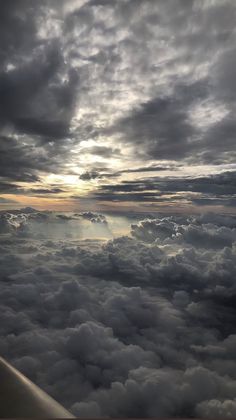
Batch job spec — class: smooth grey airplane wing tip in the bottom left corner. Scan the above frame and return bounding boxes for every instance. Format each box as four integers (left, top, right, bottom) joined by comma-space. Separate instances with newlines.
0, 357, 74, 418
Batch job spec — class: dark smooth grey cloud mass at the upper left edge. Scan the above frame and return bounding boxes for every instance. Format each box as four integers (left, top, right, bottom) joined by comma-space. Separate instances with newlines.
0, 62, 77, 141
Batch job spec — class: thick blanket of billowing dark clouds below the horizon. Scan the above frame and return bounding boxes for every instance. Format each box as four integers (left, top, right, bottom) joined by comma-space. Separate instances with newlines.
0, 209, 236, 419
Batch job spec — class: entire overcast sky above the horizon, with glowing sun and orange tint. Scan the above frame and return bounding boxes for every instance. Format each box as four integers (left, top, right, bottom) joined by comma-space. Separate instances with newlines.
0, 0, 236, 214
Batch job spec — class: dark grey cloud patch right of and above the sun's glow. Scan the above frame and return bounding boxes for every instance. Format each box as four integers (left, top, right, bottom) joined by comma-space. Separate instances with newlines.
110, 86, 236, 164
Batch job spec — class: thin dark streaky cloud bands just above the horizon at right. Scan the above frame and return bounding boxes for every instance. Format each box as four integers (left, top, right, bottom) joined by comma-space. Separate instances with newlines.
87, 171, 236, 207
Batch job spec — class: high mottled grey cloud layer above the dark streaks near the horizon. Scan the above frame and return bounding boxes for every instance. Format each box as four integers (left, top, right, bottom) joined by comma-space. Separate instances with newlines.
0, 0, 236, 201
